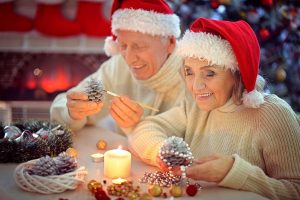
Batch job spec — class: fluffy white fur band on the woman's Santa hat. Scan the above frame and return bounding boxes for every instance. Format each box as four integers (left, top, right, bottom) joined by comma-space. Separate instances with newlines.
176, 30, 239, 71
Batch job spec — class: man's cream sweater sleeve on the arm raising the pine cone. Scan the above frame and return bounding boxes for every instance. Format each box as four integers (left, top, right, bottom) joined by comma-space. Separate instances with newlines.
50, 58, 114, 131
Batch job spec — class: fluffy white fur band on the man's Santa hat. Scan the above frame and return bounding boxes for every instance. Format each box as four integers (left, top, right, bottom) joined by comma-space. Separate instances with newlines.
112, 8, 180, 38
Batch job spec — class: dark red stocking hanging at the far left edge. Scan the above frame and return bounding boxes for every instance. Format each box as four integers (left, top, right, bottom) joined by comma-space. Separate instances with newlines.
0, 0, 33, 32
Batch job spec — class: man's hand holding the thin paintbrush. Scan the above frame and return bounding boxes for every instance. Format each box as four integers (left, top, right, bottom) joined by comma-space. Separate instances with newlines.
109, 96, 144, 128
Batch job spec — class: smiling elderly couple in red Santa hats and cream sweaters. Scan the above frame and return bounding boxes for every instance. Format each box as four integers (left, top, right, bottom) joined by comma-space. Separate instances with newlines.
51, 0, 300, 199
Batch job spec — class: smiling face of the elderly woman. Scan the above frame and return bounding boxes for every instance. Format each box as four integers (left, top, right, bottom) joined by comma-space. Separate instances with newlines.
182, 58, 235, 111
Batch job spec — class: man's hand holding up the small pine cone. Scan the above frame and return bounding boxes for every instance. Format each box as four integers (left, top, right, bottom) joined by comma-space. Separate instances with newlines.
67, 91, 103, 120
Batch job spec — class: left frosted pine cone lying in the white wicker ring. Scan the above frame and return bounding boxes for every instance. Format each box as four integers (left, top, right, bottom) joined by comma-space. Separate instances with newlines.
28, 156, 57, 176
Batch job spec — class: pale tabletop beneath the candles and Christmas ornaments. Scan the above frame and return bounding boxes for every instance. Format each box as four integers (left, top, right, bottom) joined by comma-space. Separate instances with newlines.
0, 126, 266, 200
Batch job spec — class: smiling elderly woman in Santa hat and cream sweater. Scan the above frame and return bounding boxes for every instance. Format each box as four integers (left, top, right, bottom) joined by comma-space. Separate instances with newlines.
129, 18, 300, 199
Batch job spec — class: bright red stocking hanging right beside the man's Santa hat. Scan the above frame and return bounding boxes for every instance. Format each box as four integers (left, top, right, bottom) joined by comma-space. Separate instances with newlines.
76, 0, 111, 37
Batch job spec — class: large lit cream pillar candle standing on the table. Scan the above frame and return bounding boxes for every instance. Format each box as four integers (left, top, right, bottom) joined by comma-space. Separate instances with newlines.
104, 147, 131, 178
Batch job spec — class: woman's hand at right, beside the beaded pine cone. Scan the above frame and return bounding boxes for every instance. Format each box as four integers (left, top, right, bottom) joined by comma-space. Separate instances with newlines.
186, 154, 234, 183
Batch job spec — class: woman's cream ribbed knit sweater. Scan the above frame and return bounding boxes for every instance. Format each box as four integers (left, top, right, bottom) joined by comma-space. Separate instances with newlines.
129, 95, 300, 199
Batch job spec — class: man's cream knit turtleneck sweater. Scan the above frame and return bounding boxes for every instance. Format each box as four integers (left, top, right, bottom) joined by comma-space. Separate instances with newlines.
50, 54, 185, 133
